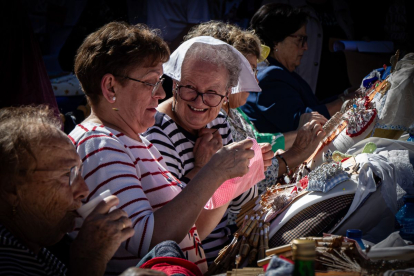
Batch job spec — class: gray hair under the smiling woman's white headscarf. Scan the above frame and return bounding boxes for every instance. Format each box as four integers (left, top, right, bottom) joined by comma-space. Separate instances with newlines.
183, 42, 241, 88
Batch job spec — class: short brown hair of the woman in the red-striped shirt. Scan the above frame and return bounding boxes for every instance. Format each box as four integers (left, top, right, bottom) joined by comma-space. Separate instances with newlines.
75, 22, 170, 104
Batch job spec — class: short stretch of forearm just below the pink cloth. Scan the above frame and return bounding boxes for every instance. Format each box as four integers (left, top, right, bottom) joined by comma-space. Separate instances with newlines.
196, 201, 230, 240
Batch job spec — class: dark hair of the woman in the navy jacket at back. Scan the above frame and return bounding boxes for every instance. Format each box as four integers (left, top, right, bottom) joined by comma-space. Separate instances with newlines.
250, 3, 308, 48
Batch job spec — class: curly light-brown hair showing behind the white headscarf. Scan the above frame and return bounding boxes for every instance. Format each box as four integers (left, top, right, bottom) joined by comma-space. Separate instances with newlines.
184, 20, 261, 59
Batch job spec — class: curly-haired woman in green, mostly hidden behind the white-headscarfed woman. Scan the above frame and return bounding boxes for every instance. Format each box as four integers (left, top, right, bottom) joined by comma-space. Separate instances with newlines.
184, 21, 326, 198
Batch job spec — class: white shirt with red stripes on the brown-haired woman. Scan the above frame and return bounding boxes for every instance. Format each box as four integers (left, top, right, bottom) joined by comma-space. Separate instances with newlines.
69, 123, 207, 275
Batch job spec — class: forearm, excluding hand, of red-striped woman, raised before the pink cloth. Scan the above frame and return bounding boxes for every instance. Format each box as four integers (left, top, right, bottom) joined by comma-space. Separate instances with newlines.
150, 165, 226, 248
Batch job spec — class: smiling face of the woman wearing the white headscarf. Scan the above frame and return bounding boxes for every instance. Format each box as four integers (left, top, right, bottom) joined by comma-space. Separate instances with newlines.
175, 59, 228, 134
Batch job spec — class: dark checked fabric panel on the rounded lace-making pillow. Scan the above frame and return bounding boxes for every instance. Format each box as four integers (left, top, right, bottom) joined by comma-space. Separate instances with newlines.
269, 194, 354, 248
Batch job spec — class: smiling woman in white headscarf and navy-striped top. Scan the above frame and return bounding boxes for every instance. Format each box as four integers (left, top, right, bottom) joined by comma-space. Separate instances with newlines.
144, 36, 273, 262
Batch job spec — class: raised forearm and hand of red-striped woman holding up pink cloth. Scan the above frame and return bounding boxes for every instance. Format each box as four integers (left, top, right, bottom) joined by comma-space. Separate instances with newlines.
150, 140, 254, 248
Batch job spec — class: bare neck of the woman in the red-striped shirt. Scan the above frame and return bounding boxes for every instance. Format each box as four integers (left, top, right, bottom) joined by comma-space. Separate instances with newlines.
85, 107, 142, 142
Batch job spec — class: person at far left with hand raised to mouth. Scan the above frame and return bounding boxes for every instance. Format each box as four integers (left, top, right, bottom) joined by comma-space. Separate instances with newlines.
0, 107, 134, 275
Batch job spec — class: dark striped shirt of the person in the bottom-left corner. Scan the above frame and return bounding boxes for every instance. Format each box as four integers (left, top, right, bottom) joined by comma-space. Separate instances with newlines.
0, 224, 66, 276
